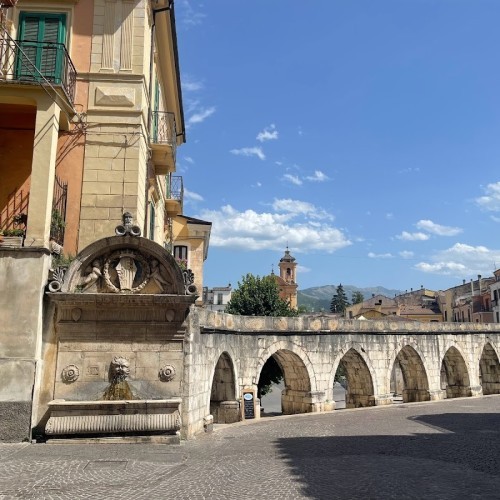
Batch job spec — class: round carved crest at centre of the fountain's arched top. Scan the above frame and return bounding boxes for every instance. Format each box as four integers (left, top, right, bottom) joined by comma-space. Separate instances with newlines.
104, 250, 151, 293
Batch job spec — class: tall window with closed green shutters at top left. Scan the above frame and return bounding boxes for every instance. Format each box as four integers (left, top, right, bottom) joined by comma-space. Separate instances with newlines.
16, 12, 66, 84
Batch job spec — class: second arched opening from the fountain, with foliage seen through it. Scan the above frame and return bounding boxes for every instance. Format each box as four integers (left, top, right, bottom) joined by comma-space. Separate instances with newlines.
258, 350, 313, 415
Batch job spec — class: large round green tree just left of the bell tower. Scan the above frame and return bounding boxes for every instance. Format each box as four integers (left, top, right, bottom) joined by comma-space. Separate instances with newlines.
225, 273, 298, 316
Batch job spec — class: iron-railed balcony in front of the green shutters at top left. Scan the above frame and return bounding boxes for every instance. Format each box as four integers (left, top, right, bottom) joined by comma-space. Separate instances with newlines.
0, 35, 76, 106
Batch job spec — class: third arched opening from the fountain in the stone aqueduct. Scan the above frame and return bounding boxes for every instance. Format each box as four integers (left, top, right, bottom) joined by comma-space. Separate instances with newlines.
333, 349, 375, 409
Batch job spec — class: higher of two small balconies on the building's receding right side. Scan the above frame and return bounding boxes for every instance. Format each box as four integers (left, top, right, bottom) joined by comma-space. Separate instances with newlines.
150, 111, 177, 175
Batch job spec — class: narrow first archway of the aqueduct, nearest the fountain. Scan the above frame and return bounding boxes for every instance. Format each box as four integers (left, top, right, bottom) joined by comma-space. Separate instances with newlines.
210, 352, 240, 424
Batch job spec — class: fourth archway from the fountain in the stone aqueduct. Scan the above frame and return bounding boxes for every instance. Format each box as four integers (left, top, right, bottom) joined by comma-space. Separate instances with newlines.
391, 345, 431, 403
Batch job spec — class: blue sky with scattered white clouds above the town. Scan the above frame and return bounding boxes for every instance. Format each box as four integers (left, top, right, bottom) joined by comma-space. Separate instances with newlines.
171, 0, 500, 291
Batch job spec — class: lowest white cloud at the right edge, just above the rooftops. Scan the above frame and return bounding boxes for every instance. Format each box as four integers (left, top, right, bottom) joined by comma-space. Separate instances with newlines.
415, 243, 500, 278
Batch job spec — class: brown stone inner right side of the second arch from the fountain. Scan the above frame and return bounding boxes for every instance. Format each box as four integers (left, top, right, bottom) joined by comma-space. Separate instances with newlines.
261, 349, 313, 415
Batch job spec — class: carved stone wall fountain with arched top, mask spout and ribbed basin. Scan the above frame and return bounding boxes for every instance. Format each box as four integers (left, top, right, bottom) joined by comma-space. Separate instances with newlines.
41, 214, 196, 442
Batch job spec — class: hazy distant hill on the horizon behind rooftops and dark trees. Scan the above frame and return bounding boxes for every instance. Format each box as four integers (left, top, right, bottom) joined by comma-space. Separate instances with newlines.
297, 285, 403, 312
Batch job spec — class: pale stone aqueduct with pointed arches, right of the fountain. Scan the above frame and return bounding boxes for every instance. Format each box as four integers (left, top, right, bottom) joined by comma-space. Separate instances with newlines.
186, 310, 500, 421
